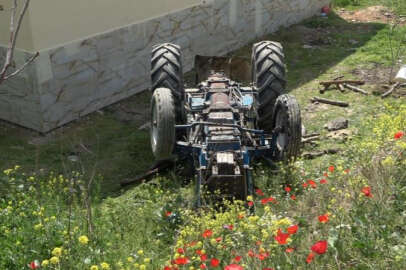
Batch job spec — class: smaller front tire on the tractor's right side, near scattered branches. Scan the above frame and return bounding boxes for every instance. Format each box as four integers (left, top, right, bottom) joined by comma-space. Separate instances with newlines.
272, 94, 302, 161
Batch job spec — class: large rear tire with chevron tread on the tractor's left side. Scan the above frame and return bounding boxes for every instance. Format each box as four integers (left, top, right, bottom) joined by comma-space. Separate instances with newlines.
151, 43, 185, 123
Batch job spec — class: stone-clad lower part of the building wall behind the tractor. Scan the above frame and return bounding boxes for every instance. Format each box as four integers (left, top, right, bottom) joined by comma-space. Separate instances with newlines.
0, 0, 329, 132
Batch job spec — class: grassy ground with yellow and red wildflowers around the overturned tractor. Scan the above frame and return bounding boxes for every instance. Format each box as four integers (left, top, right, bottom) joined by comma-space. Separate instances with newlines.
0, 1, 406, 270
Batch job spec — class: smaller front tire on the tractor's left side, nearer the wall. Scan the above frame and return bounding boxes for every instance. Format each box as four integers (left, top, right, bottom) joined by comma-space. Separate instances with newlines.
151, 88, 176, 160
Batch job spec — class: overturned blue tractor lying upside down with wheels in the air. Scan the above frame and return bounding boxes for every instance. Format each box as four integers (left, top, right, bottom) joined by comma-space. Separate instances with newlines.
151, 41, 301, 206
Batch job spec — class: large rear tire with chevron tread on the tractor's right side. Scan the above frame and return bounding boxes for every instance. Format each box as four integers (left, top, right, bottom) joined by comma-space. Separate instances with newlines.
251, 41, 286, 132
